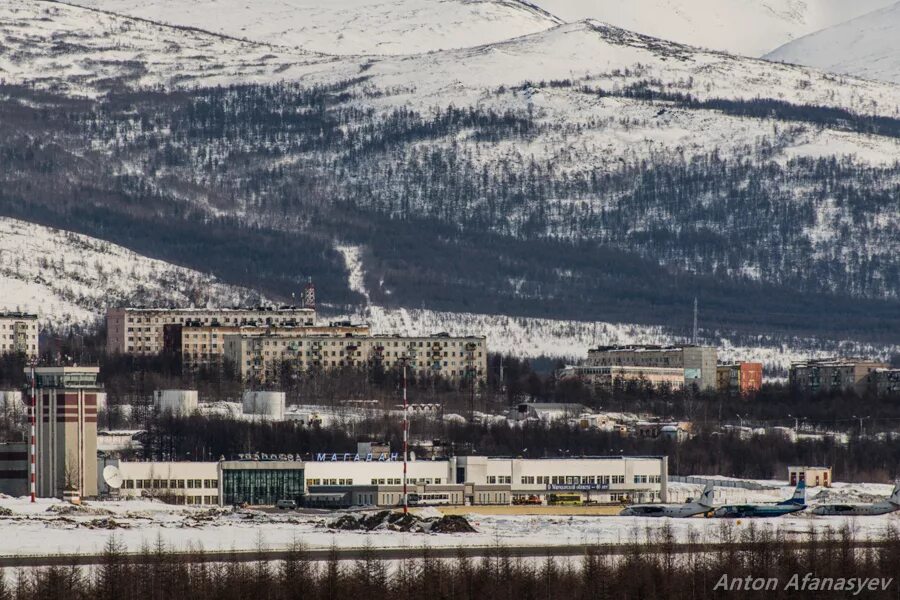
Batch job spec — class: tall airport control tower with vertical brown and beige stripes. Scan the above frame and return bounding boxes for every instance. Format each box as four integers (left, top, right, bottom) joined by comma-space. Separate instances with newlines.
26, 367, 101, 498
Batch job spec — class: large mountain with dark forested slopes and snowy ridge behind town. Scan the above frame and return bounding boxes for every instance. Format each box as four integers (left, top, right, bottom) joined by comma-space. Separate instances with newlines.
0, 0, 900, 356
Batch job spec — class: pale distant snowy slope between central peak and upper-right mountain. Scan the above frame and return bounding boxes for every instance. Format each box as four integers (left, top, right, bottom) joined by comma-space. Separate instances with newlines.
535, 0, 894, 56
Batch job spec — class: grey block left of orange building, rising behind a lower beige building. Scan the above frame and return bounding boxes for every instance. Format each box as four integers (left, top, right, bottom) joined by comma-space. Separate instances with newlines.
586, 345, 717, 390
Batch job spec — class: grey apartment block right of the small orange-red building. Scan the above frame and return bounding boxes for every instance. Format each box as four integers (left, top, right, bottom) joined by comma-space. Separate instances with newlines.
788, 358, 888, 394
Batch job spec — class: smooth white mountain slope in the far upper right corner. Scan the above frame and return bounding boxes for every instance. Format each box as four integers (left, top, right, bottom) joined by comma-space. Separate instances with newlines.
766, 2, 900, 83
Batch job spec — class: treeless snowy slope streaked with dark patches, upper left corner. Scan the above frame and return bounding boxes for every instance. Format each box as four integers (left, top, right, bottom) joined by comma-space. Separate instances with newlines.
0, 0, 344, 96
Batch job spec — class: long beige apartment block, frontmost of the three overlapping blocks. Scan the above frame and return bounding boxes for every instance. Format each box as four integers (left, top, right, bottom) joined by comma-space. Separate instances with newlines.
225, 333, 487, 384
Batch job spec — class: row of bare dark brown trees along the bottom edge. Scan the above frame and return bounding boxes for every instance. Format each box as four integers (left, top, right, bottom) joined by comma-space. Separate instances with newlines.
0, 524, 900, 600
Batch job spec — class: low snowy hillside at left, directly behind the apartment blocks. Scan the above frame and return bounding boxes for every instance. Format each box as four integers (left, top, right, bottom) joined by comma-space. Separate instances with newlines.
0, 217, 266, 324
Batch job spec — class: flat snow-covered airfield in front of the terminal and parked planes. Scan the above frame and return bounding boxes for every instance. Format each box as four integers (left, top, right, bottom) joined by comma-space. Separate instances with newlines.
0, 482, 900, 556
